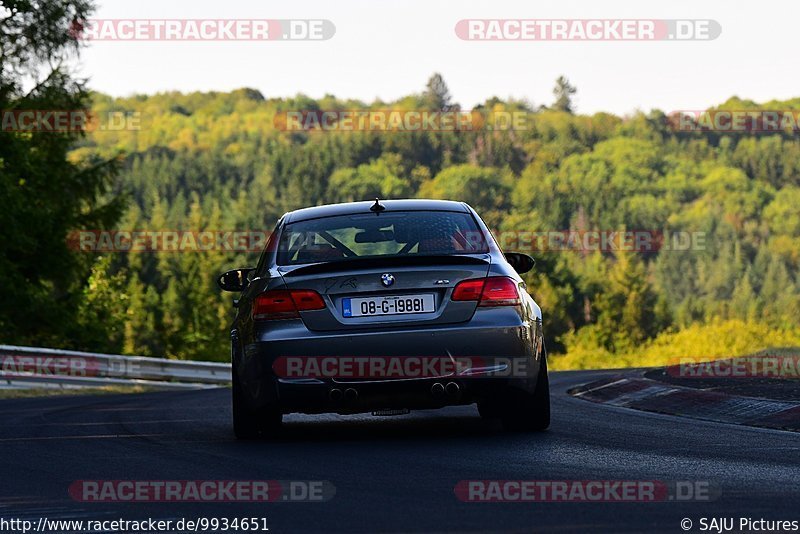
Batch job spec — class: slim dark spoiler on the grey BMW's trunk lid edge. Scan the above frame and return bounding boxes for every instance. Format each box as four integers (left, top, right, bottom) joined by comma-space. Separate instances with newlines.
278, 254, 492, 277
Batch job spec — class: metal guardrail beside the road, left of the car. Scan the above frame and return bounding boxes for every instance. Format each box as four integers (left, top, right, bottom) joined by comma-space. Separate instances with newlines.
0, 345, 231, 389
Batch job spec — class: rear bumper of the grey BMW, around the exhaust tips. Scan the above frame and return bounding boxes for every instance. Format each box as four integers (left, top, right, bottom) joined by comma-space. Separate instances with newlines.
234, 308, 541, 413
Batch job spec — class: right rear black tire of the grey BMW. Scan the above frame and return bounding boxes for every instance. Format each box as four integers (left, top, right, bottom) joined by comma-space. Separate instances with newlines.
500, 353, 550, 432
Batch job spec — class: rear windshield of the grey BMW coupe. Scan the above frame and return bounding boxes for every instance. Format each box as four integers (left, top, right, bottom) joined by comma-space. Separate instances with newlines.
278, 211, 489, 265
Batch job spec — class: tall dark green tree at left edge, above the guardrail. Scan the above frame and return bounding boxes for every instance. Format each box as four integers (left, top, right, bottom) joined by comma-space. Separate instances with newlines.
0, 0, 121, 346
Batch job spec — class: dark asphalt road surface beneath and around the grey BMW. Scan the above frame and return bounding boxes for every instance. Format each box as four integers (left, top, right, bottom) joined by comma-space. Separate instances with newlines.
0, 372, 800, 532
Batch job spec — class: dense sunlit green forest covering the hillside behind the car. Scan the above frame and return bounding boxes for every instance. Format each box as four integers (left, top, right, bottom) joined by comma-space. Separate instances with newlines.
3, 46, 800, 367
